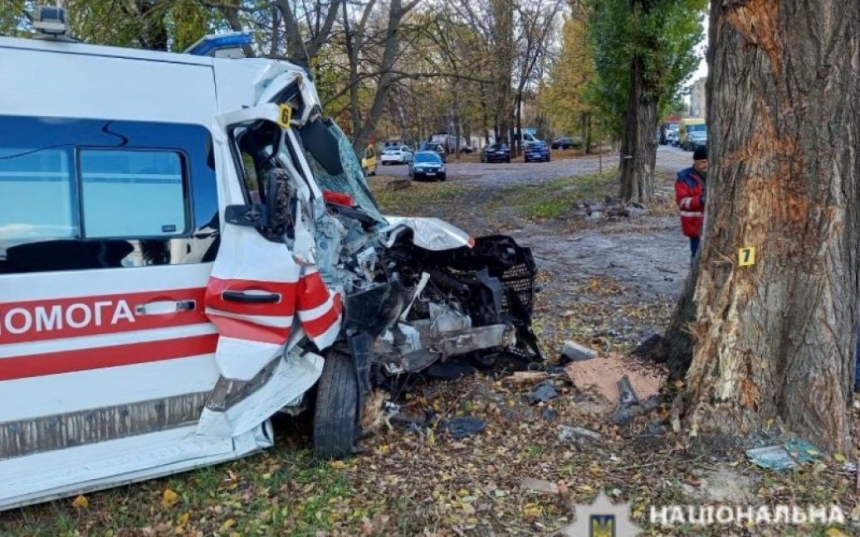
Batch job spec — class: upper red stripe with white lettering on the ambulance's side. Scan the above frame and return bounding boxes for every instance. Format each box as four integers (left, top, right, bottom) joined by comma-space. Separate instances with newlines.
0, 288, 207, 345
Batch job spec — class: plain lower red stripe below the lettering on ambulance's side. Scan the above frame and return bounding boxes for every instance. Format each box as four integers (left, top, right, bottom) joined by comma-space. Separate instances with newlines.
0, 334, 218, 381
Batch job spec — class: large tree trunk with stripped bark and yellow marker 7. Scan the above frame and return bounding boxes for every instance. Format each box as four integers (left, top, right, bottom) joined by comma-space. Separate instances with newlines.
687, 0, 860, 450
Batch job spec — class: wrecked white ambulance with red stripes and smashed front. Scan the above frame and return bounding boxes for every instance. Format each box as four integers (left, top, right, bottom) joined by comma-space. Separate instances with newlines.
0, 31, 542, 509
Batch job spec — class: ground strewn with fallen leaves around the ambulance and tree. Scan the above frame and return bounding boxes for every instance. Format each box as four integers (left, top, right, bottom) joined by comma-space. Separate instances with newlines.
0, 165, 860, 537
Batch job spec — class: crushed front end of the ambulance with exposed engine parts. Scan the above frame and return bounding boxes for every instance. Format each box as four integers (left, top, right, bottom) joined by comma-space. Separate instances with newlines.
218, 75, 543, 457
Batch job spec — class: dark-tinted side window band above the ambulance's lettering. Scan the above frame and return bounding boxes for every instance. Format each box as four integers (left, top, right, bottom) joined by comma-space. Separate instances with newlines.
0, 115, 220, 277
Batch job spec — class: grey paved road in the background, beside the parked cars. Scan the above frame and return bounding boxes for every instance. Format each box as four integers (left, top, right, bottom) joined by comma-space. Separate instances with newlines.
377, 146, 693, 185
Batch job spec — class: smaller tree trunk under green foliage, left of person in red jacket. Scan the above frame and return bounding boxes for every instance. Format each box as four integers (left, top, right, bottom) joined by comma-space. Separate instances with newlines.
619, 56, 657, 202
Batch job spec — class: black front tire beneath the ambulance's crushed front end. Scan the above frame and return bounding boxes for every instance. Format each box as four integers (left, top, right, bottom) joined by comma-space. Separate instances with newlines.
314, 352, 361, 459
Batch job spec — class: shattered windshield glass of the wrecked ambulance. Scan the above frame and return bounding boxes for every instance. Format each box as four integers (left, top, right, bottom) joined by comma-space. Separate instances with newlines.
303, 123, 387, 223
